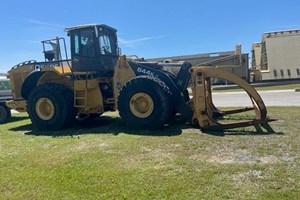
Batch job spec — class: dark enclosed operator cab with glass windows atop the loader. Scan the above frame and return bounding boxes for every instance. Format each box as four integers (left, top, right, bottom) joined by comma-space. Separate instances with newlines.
65, 24, 120, 77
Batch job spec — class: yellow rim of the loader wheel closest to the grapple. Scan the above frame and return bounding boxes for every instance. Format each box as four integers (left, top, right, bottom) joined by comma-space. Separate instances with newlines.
129, 93, 154, 118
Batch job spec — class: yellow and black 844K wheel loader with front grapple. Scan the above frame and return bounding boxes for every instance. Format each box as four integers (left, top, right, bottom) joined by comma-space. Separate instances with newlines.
6, 24, 274, 130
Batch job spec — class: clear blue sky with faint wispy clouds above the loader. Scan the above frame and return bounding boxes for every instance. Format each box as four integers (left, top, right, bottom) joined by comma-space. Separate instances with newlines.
0, 0, 300, 72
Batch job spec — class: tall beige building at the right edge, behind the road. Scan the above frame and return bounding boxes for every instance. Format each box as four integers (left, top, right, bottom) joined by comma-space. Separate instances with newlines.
251, 30, 300, 81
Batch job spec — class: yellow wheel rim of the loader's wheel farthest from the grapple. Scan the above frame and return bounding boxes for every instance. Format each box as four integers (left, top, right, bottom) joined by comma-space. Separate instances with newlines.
35, 98, 55, 120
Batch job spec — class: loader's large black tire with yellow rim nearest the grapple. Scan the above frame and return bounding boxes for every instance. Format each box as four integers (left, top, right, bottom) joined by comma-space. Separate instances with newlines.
118, 76, 173, 129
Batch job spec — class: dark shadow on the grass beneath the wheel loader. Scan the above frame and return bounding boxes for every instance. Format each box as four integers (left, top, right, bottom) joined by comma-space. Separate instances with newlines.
10, 116, 283, 137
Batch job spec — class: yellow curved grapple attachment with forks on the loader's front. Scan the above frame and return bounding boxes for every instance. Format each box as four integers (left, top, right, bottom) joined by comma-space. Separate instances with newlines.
190, 67, 277, 130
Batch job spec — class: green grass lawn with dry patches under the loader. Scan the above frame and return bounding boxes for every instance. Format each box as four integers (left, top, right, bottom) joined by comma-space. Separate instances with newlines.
0, 107, 300, 200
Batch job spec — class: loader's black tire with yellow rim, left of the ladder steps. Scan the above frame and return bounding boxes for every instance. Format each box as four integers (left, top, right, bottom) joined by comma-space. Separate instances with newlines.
28, 84, 75, 130
